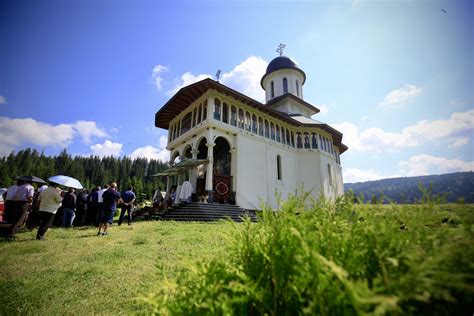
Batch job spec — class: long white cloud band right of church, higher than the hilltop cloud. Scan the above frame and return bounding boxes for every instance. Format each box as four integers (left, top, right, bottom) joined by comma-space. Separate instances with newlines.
333, 109, 474, 151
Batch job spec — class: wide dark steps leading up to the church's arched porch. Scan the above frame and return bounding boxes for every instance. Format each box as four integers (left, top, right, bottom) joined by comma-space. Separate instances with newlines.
161, 202, 257, 222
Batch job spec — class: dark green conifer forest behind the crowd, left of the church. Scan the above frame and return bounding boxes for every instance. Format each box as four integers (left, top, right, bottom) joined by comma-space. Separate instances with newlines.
0, 148, 168, 200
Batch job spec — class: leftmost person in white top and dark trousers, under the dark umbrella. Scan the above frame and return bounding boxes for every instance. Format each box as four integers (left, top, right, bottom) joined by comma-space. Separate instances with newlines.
4, 180, 35, 240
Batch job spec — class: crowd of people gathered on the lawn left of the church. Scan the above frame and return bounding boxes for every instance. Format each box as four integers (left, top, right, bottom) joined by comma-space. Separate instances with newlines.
3, 180, 139, 240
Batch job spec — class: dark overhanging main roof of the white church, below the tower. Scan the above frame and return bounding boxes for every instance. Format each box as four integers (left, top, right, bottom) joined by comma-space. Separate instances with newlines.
155, 78, 347, 153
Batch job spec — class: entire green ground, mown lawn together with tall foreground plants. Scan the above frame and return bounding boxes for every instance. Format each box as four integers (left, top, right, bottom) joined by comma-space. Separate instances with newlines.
0, 201, 474, 315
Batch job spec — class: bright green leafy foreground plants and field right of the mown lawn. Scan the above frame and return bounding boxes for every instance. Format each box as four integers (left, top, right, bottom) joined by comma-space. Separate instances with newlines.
141, 194, 474, 315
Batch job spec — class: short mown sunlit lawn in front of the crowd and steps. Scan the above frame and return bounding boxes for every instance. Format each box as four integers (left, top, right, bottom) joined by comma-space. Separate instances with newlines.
0, 221, 230, 315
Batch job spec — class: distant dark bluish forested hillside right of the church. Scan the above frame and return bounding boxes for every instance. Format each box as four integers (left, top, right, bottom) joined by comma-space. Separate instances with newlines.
344, 172, 474, 203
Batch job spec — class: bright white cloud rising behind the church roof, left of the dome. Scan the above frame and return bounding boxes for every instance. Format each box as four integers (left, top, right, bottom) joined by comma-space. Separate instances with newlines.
168, 56, 267, 101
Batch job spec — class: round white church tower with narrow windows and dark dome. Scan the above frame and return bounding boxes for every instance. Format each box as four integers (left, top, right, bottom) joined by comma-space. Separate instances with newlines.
260, 56, 306, 103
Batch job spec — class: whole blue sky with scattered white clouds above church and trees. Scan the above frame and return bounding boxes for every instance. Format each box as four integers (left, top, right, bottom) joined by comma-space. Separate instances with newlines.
0, 0, 474, 182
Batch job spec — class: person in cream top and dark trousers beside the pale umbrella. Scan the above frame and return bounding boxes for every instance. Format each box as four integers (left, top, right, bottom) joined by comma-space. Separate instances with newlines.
36, 183, 62, 240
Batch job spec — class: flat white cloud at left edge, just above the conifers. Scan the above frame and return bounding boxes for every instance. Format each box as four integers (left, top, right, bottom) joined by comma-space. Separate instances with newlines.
0, 117, 75, 155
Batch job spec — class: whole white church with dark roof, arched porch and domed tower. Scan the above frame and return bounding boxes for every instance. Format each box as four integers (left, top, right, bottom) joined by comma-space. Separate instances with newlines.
155, 56, 347, 209
